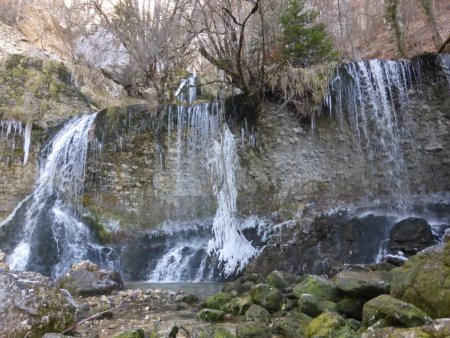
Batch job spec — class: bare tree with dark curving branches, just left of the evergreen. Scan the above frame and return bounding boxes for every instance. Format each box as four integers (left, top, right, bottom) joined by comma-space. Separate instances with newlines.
191, 0, 283, 96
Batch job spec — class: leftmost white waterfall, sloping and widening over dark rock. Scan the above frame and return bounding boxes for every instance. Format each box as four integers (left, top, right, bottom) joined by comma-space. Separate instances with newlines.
8, 113, 117, 276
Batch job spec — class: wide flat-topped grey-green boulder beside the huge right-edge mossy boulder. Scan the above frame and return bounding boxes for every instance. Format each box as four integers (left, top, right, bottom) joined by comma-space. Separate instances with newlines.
333, 270, 392, 299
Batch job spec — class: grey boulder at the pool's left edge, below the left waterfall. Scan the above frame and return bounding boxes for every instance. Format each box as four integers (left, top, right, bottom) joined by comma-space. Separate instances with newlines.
60, 261, 124, 296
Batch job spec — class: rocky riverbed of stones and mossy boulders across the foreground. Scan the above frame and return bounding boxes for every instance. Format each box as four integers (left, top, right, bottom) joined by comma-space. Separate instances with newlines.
0, 231, 450, 338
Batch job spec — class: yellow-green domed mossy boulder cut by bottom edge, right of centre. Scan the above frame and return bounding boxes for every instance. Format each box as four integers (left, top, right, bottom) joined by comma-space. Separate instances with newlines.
305, 311, 357, 338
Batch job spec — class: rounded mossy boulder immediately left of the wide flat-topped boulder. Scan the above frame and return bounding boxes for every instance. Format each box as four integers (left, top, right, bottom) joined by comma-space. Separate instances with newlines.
293, 275, 337, 301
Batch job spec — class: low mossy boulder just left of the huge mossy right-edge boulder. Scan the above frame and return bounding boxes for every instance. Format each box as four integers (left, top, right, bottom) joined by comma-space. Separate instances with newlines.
362, 295, 431, 327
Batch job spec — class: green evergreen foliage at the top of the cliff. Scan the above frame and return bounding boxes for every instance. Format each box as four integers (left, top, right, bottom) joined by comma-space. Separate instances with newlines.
280, 0, 338, 67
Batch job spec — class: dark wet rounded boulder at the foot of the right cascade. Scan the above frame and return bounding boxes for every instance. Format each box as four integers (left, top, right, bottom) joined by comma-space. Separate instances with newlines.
389, 217, 435, 254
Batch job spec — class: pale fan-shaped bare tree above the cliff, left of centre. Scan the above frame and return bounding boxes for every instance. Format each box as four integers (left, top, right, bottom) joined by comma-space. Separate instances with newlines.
94, 0, 194, 103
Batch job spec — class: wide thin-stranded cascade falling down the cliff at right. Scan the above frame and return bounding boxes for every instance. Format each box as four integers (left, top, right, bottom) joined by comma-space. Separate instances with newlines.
331, 60, 413, 208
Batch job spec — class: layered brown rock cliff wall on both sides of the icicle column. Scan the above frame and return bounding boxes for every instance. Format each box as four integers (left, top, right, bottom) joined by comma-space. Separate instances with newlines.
79, 56, 450, 228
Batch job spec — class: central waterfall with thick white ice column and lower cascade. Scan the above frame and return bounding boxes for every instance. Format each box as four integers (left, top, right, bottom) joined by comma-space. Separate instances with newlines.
148, 76, 257, 281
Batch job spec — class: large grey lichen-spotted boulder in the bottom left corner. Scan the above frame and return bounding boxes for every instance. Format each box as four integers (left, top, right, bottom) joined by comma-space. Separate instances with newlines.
0, 272, 75, 338
